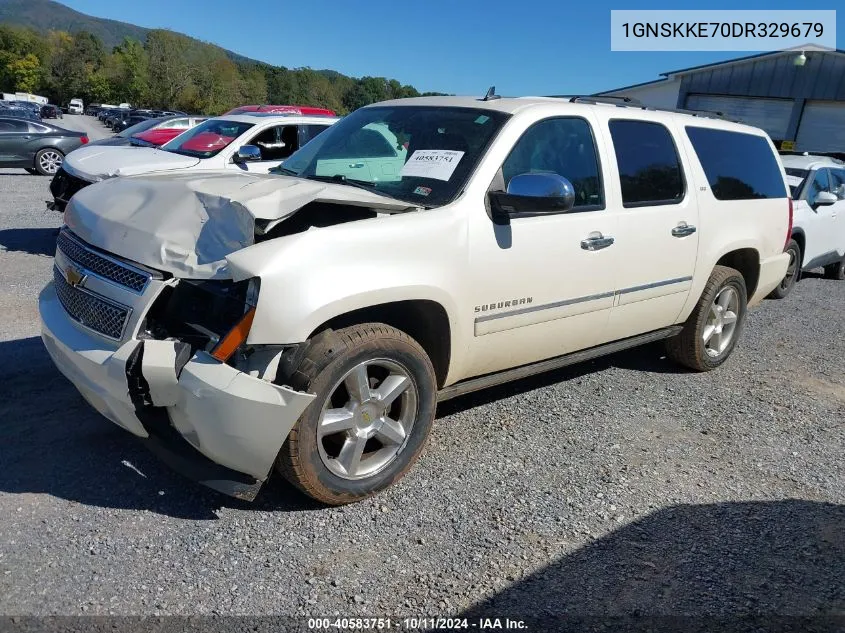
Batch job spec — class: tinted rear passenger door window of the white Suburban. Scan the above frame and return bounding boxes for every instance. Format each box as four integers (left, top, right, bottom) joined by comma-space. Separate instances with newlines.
608, 120, 684, 207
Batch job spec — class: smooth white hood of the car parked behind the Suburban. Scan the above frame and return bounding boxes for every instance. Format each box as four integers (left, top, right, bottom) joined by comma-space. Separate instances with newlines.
62, 145, 200, 182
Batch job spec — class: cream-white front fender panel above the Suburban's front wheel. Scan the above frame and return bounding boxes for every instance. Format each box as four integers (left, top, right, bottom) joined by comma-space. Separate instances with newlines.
227, 208, 471, 372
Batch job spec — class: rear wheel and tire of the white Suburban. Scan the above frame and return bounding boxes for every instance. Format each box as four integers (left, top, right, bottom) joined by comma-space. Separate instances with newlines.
666, 266, 748, 371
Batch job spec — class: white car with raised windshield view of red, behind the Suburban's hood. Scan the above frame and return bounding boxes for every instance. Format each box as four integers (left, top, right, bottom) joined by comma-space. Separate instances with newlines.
51, 113, 336, 204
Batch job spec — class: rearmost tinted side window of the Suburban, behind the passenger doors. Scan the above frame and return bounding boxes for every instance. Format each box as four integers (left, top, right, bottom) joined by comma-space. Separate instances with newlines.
686, 127, 786, 200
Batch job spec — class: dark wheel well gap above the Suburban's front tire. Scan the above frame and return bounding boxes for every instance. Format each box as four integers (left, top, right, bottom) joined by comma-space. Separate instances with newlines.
308, 299, 452, 387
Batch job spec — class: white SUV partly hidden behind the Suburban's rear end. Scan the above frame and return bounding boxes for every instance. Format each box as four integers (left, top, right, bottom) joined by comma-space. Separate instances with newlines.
772, 154, 845, 299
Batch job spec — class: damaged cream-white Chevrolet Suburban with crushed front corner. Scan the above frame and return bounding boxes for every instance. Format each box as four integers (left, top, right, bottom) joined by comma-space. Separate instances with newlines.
40, 95, 791, 504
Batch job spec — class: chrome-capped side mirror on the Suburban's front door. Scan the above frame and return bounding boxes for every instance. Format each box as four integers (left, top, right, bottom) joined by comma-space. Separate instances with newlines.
488, 173, 575, 224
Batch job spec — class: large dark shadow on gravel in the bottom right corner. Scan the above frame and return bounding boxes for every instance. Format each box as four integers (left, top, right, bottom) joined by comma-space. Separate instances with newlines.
461, 499, 845, 633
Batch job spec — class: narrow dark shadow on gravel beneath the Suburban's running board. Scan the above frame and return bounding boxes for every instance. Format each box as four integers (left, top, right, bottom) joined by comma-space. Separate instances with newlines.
437, 341, 690, 418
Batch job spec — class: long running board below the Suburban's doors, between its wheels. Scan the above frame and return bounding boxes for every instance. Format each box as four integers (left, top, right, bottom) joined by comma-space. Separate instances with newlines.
437, 325, 683, 402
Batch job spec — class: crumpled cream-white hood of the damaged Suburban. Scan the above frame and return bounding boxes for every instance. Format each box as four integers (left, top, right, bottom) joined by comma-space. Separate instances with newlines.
65, 171, 416, 279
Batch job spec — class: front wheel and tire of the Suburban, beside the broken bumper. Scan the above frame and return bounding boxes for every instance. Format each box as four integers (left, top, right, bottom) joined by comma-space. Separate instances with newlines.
276, 323, 437, 505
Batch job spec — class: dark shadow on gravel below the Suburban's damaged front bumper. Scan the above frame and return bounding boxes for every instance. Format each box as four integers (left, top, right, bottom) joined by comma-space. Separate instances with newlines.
0, 337, 322, 520
